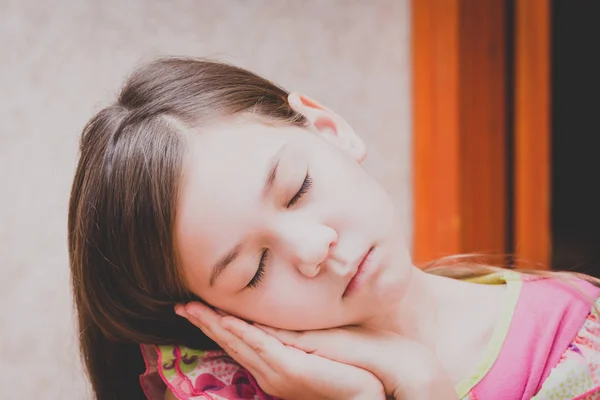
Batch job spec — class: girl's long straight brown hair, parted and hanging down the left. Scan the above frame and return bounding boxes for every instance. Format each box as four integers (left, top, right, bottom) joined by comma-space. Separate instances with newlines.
68, 58, 306, 399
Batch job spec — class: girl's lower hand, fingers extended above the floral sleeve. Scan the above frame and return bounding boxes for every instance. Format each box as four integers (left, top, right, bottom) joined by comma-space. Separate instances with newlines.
176, 302, 385, 400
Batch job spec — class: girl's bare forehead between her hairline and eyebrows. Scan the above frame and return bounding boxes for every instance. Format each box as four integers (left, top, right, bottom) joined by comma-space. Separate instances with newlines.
175, 124, 302, 281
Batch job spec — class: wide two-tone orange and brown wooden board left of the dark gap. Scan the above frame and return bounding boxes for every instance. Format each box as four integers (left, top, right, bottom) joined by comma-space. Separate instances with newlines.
412, 0, 507, 263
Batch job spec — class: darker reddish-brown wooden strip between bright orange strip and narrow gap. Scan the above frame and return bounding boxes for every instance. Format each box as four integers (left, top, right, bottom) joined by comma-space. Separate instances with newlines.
460, 0, 508, 254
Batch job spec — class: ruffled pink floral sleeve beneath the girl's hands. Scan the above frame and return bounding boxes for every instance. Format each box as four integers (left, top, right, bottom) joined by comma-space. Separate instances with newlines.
140, 345, 276, 400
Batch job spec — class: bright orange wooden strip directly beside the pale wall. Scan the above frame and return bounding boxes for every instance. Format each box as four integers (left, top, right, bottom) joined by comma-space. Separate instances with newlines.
412, 0, 461, 262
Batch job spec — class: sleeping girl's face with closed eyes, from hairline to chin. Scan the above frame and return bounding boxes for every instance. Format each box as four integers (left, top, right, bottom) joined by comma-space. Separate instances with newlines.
175, 113, 410, 330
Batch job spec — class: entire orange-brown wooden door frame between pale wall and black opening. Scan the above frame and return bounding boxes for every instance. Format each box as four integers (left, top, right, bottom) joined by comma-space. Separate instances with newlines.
412, 0, 550, 266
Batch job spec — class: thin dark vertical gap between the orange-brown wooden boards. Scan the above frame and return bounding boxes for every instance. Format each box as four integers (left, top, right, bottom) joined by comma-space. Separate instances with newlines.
504, 0, 515, 266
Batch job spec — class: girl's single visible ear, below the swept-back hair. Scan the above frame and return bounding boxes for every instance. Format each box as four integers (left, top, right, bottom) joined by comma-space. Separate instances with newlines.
288, 92, 367, 163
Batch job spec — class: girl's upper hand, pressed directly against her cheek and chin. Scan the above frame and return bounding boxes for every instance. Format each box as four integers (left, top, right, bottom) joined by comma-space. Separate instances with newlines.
256, 325, 457, 400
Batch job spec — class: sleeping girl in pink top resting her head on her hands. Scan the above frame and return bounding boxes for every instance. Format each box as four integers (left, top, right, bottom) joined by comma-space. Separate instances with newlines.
69, 59, 600, 399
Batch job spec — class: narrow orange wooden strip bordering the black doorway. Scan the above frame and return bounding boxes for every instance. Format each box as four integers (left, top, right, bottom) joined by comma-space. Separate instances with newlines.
515, 0, 551, 268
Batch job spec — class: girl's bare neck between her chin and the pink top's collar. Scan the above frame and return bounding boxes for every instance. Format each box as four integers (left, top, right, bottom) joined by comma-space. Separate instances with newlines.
365, 267, 504, 381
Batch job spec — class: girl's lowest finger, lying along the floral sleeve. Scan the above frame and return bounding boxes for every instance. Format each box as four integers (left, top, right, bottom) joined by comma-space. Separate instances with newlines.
176, 303, 271, 378
